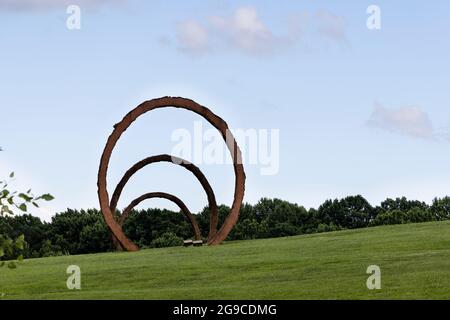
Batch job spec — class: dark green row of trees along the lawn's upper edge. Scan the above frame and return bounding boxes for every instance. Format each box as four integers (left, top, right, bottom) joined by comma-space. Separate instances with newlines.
0, 195, 450, 260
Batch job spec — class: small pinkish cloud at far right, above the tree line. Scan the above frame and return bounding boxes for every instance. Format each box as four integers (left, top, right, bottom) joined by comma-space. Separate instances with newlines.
368, 104, 435, 139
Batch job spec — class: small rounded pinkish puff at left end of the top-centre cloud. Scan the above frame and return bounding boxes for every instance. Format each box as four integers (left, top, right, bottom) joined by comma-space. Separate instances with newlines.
177, 20, 209, 53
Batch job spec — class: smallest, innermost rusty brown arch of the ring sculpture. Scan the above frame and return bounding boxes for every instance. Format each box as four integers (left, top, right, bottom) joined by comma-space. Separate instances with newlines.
119, 192, 202, 240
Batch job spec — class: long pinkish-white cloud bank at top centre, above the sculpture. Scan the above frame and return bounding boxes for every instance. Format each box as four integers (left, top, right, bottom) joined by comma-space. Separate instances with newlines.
172, 6, 347, 55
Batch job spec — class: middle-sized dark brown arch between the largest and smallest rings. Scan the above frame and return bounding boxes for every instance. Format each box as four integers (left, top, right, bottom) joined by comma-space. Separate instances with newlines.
109, 154, 218, 239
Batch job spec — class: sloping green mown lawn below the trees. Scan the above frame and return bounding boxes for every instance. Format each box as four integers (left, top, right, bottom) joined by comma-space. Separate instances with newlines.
0, 222, 450, 299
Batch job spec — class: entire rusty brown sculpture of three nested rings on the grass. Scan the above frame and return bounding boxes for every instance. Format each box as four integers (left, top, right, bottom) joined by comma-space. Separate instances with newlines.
97, 97, 245, 251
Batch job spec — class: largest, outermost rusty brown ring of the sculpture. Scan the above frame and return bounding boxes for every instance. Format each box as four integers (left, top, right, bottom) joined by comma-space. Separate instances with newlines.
97, 97, 245, 251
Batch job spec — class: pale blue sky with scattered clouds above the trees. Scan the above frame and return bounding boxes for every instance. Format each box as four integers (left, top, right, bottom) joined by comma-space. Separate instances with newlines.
0, 0, 450, 220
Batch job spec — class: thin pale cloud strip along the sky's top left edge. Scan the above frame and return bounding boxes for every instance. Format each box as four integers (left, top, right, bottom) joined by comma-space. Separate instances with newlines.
0, 0, 127, 11
